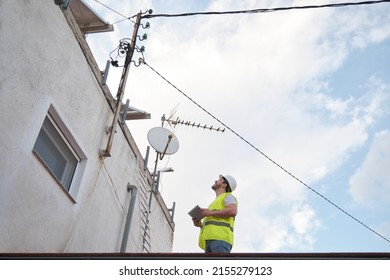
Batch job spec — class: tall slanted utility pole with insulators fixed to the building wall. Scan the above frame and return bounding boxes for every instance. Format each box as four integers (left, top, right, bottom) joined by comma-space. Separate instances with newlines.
100, 12, 142, 157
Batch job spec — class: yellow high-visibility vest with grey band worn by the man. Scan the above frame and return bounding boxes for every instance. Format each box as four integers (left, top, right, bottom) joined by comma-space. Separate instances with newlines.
199, 193, 234, 250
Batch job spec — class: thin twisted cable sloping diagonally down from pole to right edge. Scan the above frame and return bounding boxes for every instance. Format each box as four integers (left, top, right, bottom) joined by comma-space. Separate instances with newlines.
144, 61, 390, 243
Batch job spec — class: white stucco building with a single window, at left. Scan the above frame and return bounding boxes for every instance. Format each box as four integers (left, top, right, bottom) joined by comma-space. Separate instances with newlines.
0, 0, 174, 253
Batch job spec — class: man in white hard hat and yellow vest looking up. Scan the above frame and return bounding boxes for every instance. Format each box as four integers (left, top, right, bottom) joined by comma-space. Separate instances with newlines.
192, 175, 237, 253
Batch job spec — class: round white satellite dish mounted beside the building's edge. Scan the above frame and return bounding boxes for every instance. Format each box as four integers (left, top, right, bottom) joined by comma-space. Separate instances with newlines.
148, 127, 179, 155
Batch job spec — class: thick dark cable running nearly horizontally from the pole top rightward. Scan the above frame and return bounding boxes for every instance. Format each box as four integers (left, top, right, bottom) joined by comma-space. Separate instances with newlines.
142, 0, 390, 18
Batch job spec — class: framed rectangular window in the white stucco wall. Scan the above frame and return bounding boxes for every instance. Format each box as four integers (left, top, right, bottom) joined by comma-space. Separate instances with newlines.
33, 106, 86, 196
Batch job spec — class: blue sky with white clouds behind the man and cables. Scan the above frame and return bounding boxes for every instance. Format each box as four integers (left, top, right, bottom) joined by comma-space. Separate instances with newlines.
86, 0, 390, 252
